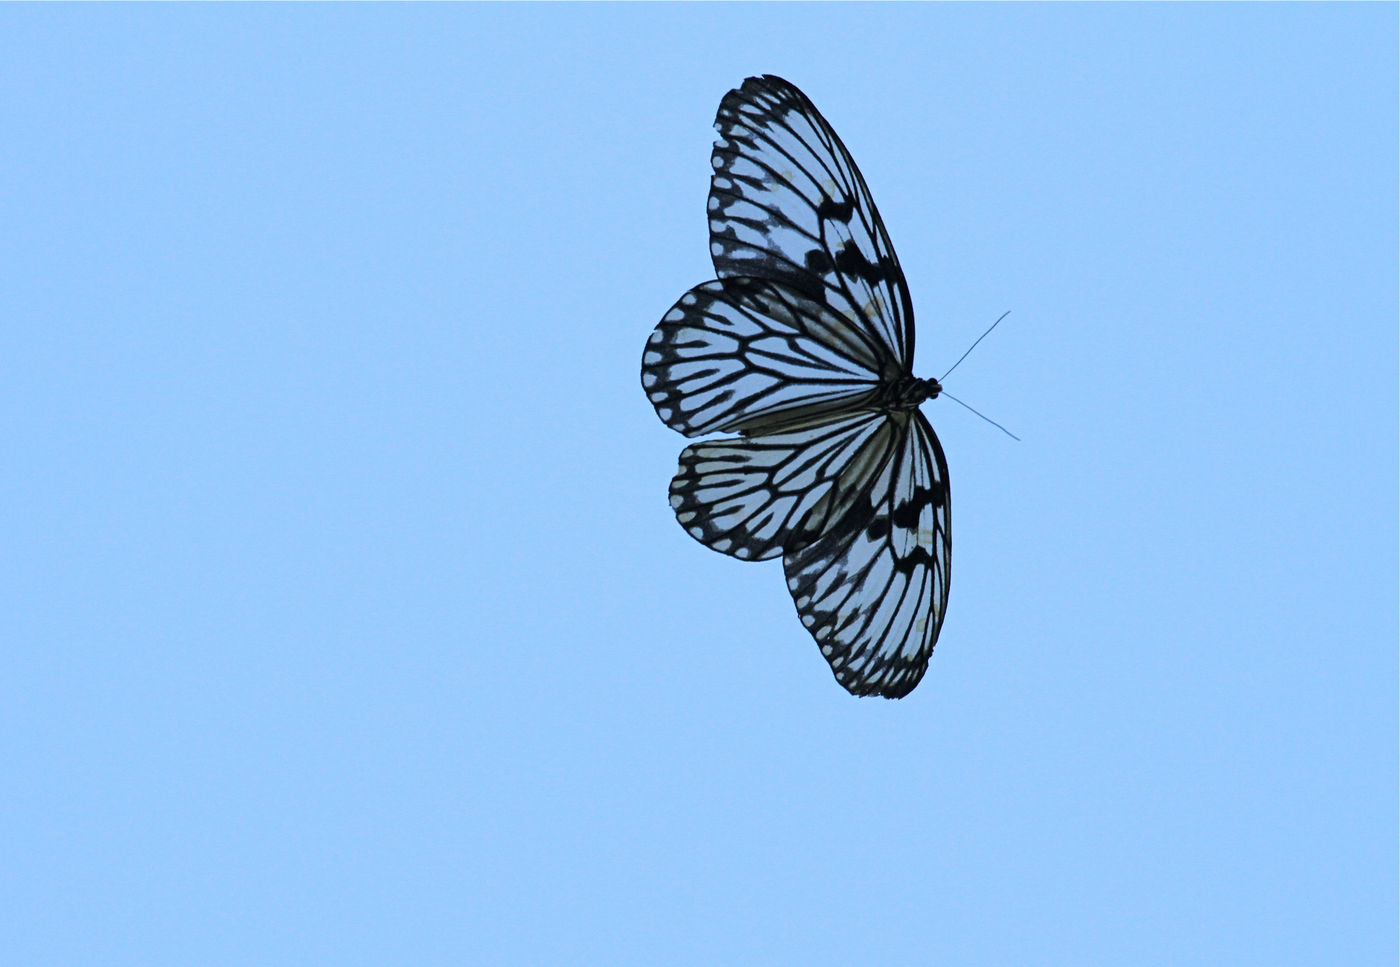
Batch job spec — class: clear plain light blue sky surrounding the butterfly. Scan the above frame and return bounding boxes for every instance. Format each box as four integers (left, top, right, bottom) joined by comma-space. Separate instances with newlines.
0, 4, 1397, 967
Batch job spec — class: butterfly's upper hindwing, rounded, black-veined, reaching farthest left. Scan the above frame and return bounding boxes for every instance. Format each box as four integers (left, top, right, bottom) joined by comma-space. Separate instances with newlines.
641, 278, 879, 437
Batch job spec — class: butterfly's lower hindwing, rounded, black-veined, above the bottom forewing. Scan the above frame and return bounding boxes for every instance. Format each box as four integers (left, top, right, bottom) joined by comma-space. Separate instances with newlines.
671, 413, 892, 561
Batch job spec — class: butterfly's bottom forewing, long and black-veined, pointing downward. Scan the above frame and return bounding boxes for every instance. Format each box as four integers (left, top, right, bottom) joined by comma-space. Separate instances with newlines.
783, 411, 952, 698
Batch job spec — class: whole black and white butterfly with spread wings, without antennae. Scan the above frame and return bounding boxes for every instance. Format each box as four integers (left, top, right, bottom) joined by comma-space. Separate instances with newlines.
641, 76, 951, 698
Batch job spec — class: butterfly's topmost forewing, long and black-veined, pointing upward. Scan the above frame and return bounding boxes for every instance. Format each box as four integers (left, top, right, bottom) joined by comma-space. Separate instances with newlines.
708, 76, 914, 369
